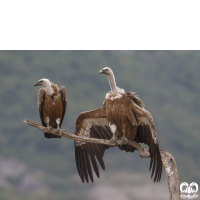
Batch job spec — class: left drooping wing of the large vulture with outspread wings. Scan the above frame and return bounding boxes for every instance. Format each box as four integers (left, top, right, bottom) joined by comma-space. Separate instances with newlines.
74, 107, 112, 183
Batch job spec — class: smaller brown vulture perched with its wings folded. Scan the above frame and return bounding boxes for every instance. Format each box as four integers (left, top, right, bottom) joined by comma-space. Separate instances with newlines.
34, 78, 67, 138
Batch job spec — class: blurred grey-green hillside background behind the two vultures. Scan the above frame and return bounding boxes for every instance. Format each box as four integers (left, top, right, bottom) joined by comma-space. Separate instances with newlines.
0, 50, 200, 200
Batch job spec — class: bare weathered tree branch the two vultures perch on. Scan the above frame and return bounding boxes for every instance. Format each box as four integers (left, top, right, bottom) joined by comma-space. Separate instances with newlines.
23, 120, 182, 200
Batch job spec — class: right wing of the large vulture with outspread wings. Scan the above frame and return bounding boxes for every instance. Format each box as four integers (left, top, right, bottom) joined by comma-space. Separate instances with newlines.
129, 94, 162, 182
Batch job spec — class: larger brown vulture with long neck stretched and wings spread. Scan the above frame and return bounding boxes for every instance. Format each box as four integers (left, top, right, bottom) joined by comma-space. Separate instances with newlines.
74, 67, 162, 183
